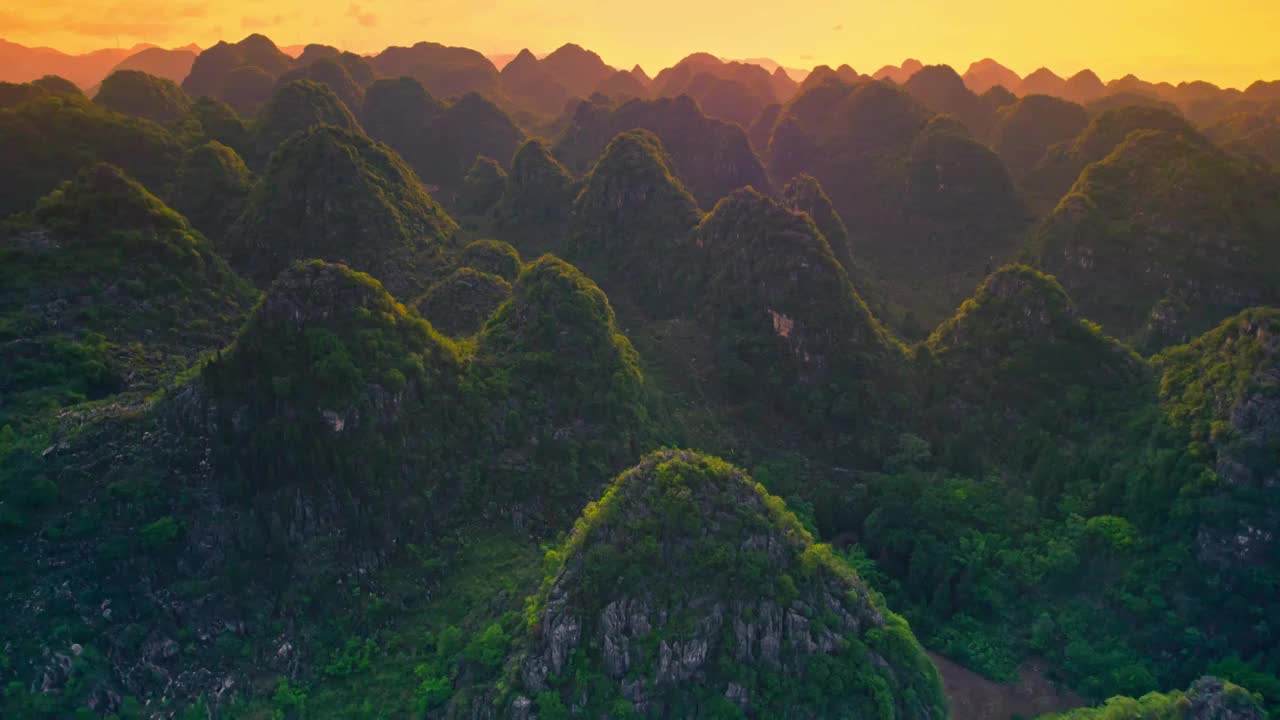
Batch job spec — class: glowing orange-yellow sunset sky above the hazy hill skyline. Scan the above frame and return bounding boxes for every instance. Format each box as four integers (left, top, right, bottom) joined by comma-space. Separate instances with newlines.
0, 0, 1280, 87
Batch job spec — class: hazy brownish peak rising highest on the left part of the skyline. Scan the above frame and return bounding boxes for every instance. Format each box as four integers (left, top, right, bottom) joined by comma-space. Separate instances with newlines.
182, 35, 293, 115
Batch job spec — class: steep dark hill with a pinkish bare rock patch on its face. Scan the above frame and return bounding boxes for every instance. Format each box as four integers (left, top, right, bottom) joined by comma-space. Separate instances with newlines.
687, 188, 906, 430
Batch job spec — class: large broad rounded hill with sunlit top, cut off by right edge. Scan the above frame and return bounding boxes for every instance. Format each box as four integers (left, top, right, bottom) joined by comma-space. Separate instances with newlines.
1032, 131, 1280, 350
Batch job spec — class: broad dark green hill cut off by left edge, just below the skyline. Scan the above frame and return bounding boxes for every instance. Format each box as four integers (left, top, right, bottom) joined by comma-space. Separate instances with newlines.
0, 95, 182, 217
